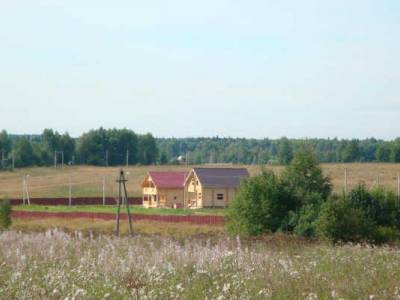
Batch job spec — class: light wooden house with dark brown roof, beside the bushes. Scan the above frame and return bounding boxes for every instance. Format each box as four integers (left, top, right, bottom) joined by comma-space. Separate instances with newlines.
184, 168, 249, 208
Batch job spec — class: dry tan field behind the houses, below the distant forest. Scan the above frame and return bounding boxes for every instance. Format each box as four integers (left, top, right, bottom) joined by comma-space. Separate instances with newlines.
0, 163, 400, 198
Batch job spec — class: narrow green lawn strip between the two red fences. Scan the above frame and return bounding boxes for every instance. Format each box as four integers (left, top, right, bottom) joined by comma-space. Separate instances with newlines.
13, 205, 225, 216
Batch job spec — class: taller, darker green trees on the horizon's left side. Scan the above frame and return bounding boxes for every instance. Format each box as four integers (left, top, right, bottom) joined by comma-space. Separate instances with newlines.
0, 128, 158, 168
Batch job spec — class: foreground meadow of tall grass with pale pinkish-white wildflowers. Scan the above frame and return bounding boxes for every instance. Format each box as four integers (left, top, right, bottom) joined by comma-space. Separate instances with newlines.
0, 229, 400, 299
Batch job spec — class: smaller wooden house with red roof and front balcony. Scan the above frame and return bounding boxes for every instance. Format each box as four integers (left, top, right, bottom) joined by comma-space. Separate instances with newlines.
142, 172, 187, 207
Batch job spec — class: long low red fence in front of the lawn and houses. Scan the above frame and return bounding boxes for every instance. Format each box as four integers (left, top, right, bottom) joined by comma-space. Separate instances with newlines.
11, 211, 224, 225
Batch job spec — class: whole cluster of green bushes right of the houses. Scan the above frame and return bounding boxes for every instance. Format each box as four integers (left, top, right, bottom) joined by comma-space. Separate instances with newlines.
227, 145, 400, 243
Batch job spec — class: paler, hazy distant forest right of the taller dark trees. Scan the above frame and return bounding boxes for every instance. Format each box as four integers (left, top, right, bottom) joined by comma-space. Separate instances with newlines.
157, 137, 400, 164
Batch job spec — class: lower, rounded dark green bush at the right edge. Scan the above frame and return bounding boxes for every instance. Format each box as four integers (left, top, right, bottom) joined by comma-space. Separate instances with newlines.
316, 185, 400, 243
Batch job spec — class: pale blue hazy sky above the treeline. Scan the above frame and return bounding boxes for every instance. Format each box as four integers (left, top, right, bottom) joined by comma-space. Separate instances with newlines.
0, 0, 400, 139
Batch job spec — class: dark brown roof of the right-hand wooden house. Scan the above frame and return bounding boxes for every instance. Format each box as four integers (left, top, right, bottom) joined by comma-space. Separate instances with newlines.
193, 168, 249, 188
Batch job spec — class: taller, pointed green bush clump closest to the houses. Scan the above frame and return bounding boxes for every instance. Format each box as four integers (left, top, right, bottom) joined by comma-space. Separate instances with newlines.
228, 145, 332, 237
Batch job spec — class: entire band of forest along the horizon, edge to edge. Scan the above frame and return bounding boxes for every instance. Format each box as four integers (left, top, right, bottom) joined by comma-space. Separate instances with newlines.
0, 128, 400, 168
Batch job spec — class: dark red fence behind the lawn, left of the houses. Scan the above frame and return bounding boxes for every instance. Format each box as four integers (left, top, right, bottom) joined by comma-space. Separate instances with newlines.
10, 197, 142, 205
